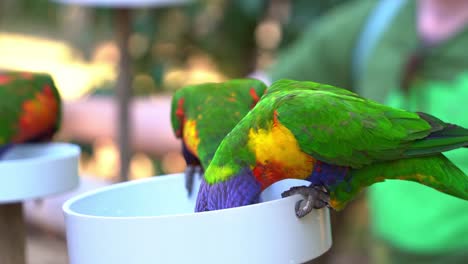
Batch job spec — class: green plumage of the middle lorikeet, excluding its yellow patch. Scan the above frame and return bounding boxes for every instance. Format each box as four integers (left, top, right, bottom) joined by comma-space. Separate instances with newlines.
171, 79, 266, 168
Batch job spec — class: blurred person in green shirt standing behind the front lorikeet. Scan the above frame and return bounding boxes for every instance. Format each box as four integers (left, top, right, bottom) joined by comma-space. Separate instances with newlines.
253, 0, 468, 263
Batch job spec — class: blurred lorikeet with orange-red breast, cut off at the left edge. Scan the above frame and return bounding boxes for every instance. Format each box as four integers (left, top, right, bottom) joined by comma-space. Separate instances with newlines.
0, 72, 61, 159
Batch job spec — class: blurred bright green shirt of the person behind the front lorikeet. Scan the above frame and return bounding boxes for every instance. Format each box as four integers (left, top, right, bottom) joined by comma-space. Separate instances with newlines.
269, 1, 468, 253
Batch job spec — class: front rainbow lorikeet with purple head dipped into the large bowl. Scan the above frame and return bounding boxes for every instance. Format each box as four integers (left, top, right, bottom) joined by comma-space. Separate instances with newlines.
196, 80, 468, 217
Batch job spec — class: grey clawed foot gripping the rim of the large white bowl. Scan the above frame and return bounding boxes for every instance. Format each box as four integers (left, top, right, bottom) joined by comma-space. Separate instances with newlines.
281, 185, 330, 218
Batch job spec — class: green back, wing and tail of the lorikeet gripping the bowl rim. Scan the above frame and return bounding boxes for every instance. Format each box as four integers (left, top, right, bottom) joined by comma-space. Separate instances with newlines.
268, 81, 468, 209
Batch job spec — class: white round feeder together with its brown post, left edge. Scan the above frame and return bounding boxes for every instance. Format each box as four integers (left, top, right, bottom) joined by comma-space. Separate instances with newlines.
0, 143, 80, 264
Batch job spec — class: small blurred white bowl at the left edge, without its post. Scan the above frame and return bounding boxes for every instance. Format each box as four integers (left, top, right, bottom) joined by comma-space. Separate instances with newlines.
0, 143, 80, 203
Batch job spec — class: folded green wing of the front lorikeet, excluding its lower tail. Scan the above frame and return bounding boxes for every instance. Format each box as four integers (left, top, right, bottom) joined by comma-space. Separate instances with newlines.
266, 80, 468, 168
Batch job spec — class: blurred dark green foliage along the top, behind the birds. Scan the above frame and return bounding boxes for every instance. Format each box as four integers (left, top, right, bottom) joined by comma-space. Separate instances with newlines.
0, 0, 347, 95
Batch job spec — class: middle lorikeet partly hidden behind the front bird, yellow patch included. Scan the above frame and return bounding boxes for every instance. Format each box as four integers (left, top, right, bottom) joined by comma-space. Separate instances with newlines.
171, 79, 266, 195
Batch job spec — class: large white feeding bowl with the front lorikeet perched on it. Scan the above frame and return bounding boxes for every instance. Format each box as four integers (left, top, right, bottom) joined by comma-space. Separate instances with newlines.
63, 174, 332, 264
